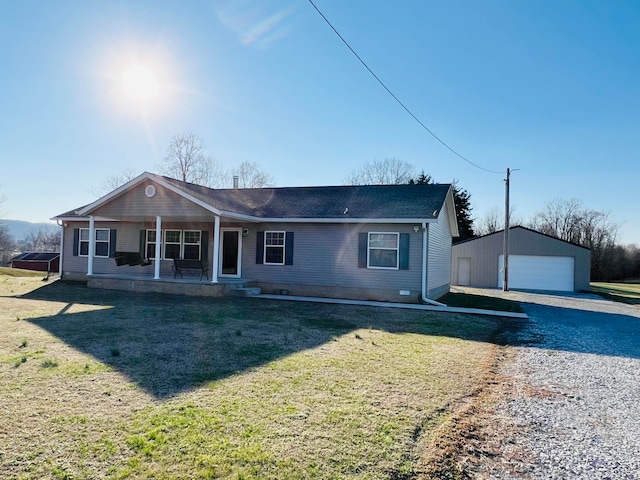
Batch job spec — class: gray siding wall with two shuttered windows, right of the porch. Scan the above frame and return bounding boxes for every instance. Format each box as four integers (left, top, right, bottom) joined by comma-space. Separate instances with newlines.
242, 223, 422, 295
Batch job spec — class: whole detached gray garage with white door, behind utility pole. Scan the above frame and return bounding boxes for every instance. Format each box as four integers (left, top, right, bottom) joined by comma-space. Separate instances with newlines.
451, 227, 591, 291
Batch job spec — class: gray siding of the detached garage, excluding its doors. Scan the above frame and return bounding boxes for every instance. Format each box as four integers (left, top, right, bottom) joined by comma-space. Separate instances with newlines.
451, 227, 591, 291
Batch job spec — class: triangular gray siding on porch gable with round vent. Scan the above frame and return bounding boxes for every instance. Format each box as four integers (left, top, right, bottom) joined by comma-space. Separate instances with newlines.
92, 182, 213, 221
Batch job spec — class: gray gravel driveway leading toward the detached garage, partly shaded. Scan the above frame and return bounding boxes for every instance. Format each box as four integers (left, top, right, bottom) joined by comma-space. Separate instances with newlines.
456, 289, 640, 480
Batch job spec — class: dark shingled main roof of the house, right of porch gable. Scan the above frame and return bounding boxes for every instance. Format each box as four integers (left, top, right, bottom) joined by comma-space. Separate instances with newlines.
161, 177, 450, 219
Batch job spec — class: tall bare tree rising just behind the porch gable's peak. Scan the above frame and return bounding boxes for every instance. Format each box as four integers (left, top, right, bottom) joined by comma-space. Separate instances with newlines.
160, 132, 228, 188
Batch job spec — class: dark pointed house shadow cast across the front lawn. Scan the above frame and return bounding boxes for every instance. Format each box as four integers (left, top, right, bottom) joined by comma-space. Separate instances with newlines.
22, 282, 524, 399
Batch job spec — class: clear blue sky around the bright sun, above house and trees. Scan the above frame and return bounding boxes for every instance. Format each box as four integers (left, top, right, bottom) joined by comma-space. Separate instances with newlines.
0, 0, 640, 243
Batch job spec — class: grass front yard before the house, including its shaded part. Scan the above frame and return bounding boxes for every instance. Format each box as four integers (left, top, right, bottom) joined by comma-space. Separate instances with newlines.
0, 275, 510, 479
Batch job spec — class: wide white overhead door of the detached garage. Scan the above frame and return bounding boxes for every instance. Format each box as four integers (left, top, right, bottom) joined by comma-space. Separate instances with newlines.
498, 255, 574, 292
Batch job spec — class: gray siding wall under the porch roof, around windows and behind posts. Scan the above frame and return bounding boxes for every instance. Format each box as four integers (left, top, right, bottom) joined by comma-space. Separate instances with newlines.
62, 220, 213, 276
